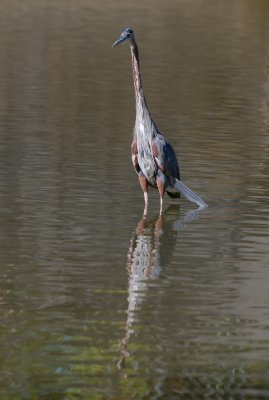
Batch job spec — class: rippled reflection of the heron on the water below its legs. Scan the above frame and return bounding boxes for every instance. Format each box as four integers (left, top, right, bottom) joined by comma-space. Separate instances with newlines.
118, 205, 205, 368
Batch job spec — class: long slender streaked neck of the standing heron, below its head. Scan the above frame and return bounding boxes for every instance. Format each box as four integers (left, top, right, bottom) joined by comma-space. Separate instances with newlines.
131, 39, 149, 118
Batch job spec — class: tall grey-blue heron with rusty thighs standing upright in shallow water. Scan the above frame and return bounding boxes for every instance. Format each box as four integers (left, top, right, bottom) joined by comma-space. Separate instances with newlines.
113, 28, 207, 216
